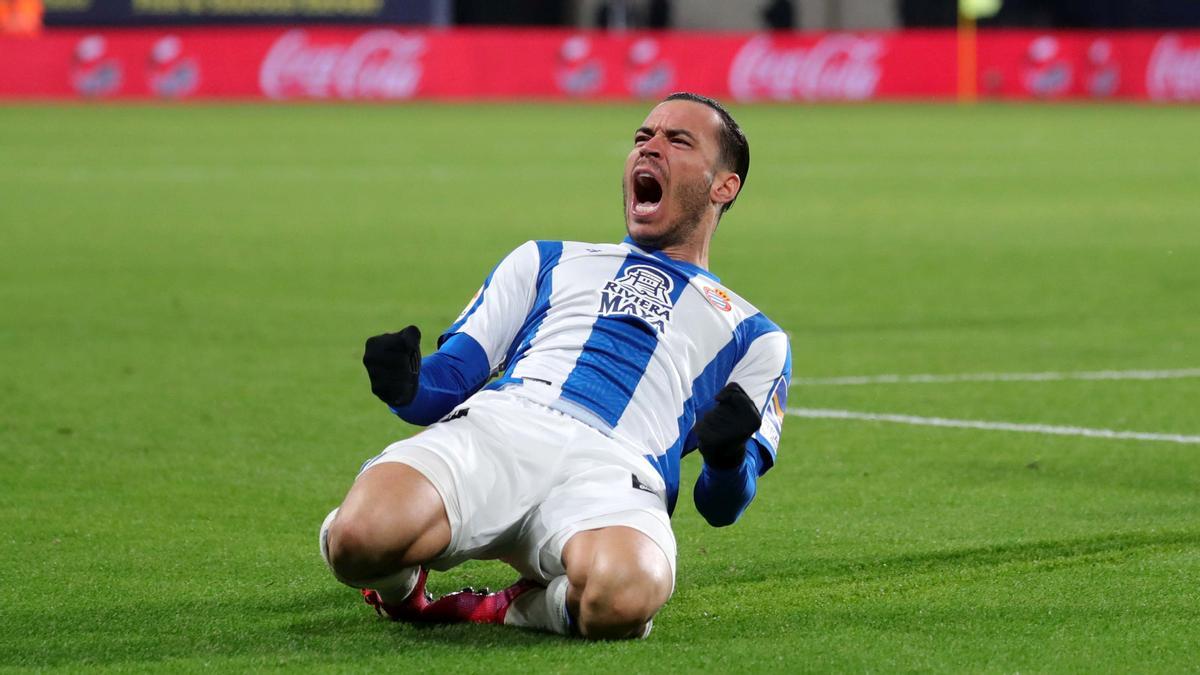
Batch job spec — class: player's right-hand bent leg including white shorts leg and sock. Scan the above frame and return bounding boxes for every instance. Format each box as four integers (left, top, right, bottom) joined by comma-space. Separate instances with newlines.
504, 425, 677, 639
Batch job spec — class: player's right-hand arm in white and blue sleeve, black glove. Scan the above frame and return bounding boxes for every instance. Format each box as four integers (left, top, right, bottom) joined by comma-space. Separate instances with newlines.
692, 331, 792, 527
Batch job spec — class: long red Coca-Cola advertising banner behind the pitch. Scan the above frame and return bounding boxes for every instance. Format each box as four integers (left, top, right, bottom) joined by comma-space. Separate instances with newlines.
0, 28, 1200, 101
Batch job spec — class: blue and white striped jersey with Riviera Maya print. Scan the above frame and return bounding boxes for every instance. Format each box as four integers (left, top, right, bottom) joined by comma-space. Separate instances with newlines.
439, 239, 791, 506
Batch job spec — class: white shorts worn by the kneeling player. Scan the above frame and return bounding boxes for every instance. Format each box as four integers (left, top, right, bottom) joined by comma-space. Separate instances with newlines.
362, 390, 676, 584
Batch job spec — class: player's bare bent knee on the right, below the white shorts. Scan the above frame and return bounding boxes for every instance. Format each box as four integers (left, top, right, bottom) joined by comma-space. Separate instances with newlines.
563, 526, 674, 639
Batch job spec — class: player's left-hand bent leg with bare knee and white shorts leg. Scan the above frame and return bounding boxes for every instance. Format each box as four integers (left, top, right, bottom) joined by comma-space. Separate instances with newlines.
322, 392, 551, 607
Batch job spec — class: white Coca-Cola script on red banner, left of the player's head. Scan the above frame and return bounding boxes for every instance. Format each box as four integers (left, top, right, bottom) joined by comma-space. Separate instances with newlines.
258, 30, 426, 98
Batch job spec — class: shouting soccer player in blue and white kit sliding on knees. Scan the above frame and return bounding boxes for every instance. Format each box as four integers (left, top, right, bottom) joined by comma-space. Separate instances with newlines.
320, 92, 791, 639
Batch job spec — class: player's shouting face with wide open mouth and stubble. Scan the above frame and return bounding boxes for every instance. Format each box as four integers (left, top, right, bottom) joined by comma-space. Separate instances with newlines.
622, 101, 721, 249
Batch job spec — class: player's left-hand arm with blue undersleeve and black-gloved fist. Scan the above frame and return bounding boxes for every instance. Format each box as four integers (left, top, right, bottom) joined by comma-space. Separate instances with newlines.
362, 241, 540, 426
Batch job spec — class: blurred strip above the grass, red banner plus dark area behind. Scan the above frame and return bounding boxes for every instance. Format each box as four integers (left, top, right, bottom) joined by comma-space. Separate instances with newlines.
7, 0, 1200, 101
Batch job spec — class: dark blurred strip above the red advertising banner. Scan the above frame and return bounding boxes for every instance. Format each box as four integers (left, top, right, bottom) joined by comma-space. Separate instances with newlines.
9, 0, 1200, 30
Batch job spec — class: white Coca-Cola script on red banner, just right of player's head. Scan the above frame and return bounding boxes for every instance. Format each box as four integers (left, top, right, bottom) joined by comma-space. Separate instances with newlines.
730, 35, 886, 101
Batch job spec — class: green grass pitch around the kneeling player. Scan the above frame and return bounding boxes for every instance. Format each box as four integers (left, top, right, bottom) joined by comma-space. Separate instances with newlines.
0, 104, 1200, 673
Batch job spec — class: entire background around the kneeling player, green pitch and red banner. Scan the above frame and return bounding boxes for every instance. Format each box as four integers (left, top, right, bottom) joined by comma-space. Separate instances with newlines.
0, 0, 1200, 673
